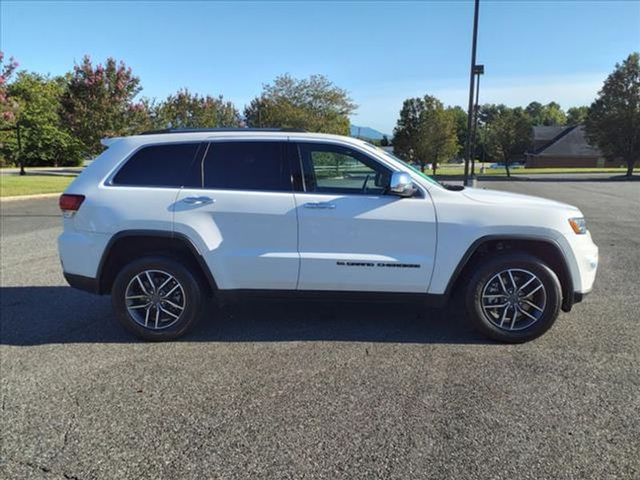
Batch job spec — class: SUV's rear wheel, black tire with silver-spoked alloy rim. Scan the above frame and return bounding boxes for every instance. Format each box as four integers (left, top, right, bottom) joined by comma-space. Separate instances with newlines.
111, 257, 202, 341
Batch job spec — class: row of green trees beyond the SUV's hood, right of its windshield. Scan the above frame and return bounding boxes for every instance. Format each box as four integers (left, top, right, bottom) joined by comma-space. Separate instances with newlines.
393, 53, 640, 176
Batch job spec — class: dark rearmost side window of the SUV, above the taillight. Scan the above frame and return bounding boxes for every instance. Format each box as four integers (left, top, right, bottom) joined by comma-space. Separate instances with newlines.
113, 143, 199, 187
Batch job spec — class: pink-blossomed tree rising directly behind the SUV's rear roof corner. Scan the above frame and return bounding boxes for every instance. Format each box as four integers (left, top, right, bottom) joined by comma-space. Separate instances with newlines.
61, 56, 141, 155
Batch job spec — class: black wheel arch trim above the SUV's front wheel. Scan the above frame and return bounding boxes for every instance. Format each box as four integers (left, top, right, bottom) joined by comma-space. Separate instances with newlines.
445, 235, 574, 312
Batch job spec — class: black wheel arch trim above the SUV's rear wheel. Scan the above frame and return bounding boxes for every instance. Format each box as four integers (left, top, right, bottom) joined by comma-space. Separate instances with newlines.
96, 230, 218, 295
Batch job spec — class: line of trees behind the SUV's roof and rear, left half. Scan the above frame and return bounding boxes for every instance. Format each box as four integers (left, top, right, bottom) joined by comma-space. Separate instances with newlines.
0, 52, 357, 166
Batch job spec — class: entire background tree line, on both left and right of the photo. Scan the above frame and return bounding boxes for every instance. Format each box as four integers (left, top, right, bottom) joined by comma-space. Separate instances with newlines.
0, 52, 640, 178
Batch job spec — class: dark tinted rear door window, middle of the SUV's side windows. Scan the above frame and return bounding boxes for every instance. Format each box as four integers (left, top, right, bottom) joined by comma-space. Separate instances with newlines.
202, 142, 291, 192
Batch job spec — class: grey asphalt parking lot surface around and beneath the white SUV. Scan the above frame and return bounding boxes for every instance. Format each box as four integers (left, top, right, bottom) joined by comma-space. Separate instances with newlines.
0, 180, 640, 480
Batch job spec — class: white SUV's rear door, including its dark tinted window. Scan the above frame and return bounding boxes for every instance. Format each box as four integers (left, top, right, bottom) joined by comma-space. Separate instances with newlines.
173, 138, 299, 290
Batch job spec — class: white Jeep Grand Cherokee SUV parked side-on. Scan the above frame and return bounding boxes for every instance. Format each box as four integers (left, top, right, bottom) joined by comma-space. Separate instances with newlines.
59, 129, 598, 342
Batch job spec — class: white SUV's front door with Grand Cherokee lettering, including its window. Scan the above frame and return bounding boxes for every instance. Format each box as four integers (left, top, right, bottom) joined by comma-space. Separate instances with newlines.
292, 142, 436, 293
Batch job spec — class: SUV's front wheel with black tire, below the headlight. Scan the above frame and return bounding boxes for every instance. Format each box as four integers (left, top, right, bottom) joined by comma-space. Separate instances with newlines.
465, 253, 562, 343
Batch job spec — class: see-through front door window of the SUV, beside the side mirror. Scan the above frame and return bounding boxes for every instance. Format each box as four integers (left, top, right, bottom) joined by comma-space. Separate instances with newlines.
298, 143, 391, 195
